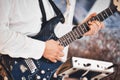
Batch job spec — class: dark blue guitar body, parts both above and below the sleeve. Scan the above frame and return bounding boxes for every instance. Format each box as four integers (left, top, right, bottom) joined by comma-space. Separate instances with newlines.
11, 17, 62, 80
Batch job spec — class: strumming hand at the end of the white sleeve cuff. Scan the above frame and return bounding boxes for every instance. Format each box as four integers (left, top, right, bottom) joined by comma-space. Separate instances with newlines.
43, 40, 64, 62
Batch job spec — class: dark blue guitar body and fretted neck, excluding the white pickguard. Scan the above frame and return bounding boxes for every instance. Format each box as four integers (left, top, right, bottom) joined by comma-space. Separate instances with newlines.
1, 0, 120, 80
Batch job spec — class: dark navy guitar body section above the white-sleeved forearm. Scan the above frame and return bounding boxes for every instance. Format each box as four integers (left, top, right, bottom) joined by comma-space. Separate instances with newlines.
32, 17, 60, 41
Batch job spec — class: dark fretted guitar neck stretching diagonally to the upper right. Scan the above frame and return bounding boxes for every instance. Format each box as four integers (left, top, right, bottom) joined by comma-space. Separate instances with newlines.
58, 6, 117, 47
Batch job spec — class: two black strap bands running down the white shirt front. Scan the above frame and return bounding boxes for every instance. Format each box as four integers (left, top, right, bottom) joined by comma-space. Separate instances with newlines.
39, 0, 65, 29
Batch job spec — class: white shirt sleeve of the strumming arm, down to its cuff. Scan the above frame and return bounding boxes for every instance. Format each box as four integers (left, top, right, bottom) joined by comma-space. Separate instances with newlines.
0, 0, 45, 59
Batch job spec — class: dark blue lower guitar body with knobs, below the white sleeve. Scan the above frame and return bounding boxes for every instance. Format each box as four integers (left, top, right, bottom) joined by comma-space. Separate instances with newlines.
11, 57, 62, 80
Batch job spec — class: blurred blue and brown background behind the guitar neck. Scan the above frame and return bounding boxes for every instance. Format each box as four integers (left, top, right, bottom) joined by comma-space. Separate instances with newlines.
54, 0, 120, 80
